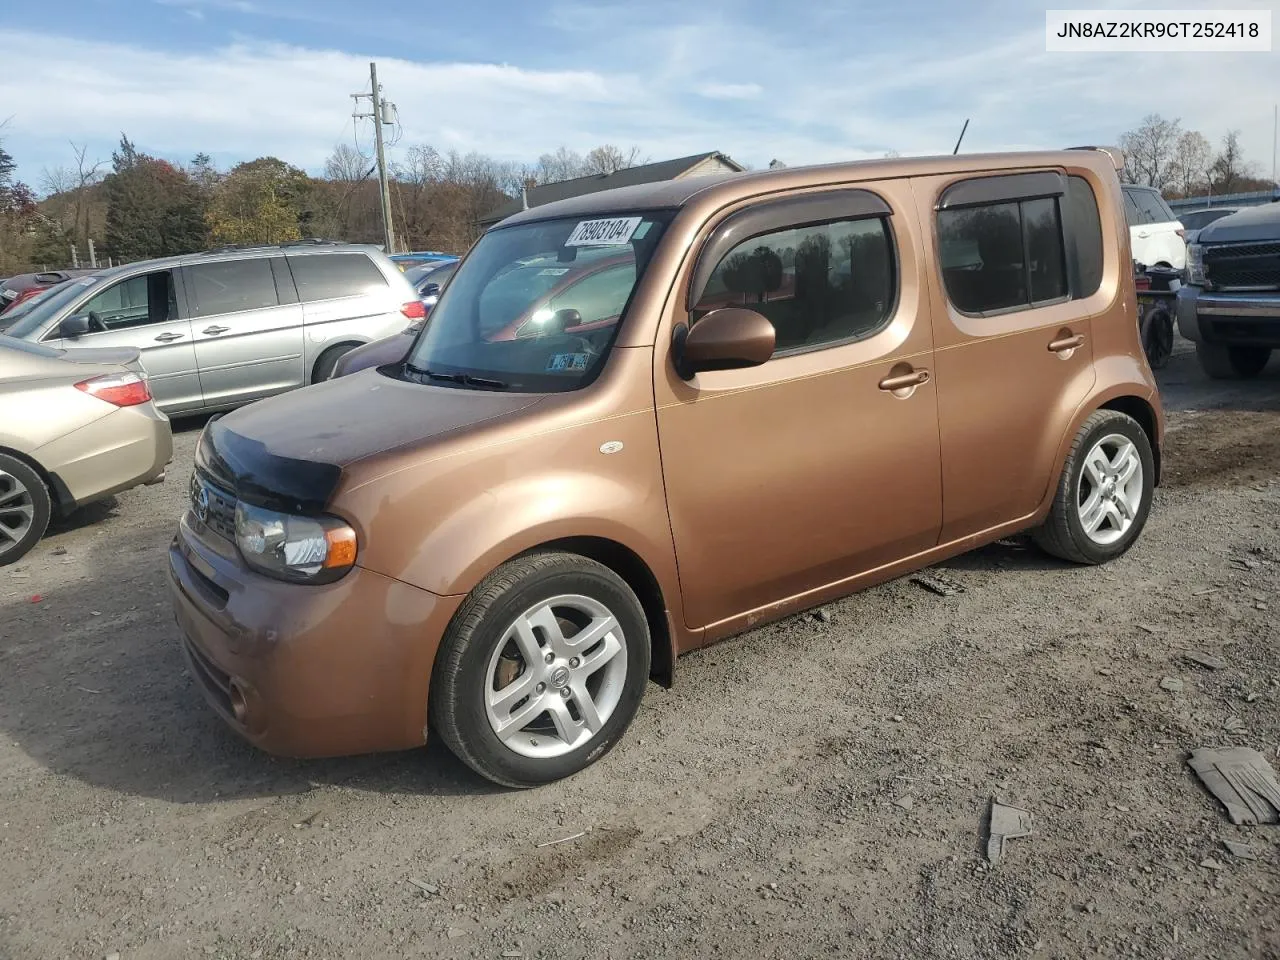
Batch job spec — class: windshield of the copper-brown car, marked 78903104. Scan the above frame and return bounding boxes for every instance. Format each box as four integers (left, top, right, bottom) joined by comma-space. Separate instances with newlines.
401, 212, 671, 393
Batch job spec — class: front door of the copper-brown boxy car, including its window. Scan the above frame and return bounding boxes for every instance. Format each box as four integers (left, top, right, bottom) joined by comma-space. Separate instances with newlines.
655, 184, 942, 634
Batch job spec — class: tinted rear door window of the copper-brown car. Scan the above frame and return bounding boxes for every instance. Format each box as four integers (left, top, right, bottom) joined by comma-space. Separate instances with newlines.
938, 197, 1066, 314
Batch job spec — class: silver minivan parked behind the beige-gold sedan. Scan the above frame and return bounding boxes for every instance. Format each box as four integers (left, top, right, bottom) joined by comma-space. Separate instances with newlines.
4, 242, 424, 415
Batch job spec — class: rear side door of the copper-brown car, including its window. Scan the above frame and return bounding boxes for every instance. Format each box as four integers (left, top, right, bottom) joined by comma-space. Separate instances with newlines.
914, 170, 1105, 543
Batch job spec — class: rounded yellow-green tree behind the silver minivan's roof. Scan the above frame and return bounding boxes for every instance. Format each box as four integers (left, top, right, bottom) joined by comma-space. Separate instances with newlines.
207, 156, 312, 243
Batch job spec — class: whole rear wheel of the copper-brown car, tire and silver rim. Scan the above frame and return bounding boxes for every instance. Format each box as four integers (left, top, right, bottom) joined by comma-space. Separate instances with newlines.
1032, 410, 1156, 563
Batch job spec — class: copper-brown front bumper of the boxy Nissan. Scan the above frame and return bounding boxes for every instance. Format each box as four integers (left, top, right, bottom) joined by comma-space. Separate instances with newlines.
169, 512, 462, 756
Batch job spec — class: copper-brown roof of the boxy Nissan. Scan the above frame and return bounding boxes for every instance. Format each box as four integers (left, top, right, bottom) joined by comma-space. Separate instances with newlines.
490, 147, 1119, 230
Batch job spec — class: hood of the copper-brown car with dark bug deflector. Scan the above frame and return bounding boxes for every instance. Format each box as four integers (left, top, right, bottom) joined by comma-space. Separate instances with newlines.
196, 370, 543, 512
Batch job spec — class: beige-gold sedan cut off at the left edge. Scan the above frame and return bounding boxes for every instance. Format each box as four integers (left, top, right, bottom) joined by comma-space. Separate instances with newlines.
0, 337, 173, 566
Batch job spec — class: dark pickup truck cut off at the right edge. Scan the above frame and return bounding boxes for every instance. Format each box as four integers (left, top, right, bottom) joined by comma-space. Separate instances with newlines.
1178, 202, 1280, 379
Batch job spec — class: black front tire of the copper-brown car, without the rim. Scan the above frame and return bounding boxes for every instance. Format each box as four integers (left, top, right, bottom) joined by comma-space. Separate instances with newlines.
430, 552, 650, 788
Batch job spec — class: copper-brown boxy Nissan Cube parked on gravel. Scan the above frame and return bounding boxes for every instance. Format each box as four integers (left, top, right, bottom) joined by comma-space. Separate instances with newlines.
169, 148, 1164, 787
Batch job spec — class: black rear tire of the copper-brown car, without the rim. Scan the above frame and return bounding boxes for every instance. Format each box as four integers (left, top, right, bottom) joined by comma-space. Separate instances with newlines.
1032, 410, 1156, 564
